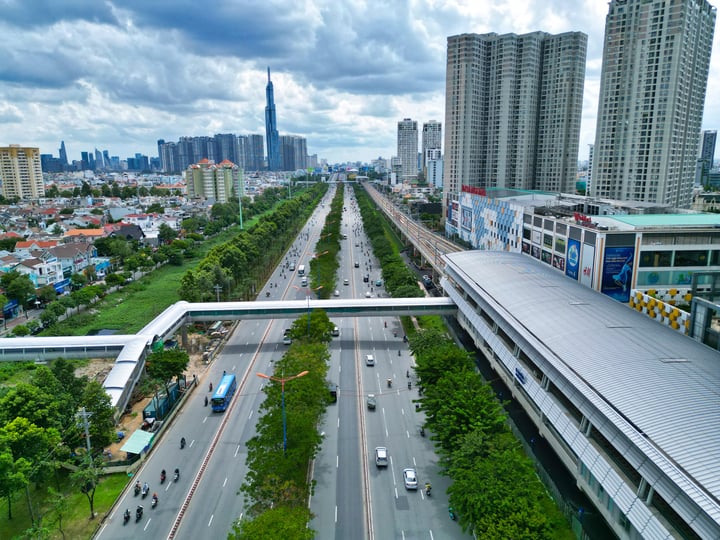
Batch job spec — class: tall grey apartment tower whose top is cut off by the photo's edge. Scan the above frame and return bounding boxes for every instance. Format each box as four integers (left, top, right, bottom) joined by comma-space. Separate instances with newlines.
591, 0, 716, 208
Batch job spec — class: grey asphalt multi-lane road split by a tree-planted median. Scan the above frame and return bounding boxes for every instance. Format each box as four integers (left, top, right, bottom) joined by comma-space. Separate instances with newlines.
96, 184, 467, 540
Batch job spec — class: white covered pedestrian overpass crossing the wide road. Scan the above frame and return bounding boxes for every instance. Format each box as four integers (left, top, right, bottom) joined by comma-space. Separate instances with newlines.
0, 297, 457, 414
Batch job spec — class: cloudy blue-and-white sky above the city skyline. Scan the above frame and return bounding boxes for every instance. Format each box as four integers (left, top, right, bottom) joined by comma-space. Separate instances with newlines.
0, 0, 720, 163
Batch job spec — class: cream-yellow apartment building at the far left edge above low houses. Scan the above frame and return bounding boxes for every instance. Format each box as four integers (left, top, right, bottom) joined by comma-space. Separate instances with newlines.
0, 144, 45, 200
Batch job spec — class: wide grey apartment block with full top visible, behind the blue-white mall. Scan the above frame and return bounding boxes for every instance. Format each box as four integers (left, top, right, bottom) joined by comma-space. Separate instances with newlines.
443, 32, 587, 207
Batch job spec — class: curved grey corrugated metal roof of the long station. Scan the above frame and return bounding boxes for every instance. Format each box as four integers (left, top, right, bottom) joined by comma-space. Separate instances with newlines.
445, 251, 720, 506
